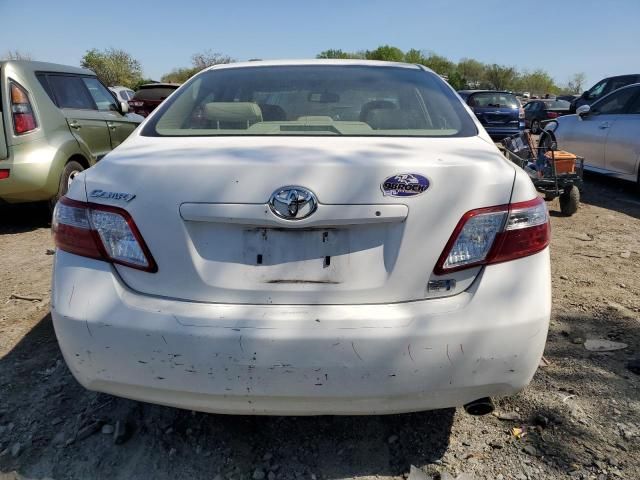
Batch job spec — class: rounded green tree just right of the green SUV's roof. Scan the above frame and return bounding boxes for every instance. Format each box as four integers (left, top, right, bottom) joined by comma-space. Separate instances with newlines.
80, 48, 142, 87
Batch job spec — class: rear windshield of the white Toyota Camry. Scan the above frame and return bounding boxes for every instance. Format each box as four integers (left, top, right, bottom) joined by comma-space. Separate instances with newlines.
142, 65, 477, 137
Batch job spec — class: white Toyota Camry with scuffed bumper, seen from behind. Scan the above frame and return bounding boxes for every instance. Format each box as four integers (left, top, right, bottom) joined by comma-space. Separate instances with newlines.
52, 61, 551, 415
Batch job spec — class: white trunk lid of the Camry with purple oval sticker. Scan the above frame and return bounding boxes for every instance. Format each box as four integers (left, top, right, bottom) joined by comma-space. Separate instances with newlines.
86, 136, 514, 304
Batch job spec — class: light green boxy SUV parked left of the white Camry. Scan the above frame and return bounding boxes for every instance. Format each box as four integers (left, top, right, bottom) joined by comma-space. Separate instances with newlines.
0, 61, 143, 204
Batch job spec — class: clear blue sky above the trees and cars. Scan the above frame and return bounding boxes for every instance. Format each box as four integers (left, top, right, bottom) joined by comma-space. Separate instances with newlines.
0, 0, 640, 86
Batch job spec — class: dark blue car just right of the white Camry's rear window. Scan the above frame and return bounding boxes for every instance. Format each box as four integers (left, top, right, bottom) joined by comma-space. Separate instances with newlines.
458, 90, 524, 140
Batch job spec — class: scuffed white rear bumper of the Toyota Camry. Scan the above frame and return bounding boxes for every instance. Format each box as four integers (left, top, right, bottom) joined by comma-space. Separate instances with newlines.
52, 250, 551, 415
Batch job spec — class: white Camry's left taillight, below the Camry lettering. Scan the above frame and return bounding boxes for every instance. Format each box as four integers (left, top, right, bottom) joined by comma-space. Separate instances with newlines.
52, 197, 158, 272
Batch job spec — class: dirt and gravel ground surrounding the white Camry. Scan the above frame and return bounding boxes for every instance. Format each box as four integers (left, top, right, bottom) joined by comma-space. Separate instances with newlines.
0, 177, 640, 480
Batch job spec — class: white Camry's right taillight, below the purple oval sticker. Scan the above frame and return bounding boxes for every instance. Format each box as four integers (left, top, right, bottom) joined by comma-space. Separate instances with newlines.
434, 197, 551, 275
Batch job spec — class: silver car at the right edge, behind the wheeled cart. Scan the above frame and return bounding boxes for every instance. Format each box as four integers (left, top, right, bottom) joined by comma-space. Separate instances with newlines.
547, 83, 640, 184
